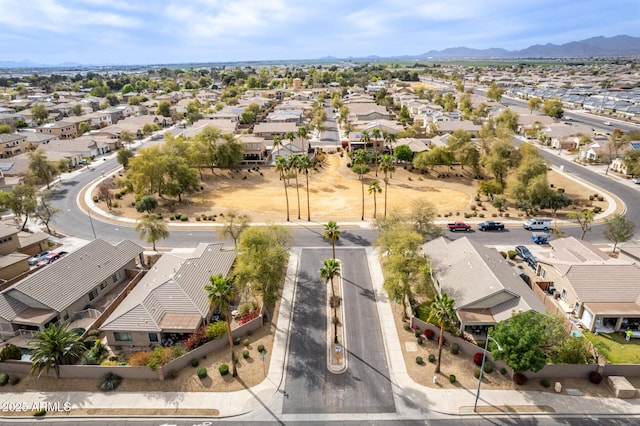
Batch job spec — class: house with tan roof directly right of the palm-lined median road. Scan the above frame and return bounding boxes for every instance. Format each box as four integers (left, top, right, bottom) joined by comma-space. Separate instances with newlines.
422, 237, 546, 340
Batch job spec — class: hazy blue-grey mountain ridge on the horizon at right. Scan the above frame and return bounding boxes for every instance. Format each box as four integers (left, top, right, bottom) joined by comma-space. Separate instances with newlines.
418, 35, 640, 59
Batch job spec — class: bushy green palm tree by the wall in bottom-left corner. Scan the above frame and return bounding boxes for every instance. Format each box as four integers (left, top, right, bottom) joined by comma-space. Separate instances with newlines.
29, 323, 86, 379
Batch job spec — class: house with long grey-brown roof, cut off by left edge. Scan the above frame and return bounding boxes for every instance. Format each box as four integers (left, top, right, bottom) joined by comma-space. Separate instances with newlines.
0, 240, 143, 340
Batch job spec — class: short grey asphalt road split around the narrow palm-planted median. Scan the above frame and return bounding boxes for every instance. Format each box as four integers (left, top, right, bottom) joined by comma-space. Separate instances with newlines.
282, 248, 395, 414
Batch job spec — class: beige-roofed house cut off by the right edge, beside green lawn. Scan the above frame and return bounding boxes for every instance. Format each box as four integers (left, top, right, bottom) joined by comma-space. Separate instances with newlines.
536, 237, 640, 336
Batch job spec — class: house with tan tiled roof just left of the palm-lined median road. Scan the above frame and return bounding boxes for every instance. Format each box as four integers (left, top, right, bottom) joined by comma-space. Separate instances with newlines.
100, 243, 236, 346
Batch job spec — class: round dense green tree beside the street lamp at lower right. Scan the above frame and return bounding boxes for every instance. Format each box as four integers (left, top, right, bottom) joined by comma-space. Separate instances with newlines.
489, 311, 549, 373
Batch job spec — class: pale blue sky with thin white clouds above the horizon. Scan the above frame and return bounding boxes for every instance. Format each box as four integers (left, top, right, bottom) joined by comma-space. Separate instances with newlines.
0, 0, 640, 65
